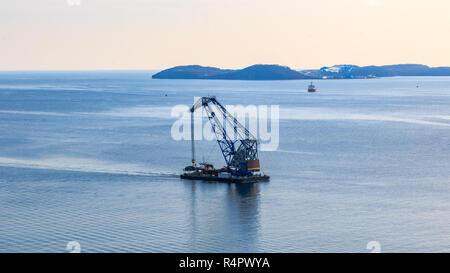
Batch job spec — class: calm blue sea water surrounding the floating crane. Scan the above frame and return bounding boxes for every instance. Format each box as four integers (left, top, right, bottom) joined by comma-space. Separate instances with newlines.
0, 72, 450, 252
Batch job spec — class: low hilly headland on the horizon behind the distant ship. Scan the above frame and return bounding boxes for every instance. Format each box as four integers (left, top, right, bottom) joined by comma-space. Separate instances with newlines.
152, 64, 450, 81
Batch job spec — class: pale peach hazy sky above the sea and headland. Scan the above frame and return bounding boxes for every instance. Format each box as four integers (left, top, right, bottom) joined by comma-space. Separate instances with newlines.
0, 0, 450, 70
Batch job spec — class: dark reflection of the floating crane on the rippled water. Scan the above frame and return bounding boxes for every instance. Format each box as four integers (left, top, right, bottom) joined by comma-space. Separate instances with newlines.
184, 181, 260, 252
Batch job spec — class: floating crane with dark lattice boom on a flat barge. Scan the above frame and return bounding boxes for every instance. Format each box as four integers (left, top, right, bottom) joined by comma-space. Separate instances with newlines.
181, 97, 269, 183
